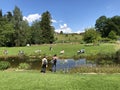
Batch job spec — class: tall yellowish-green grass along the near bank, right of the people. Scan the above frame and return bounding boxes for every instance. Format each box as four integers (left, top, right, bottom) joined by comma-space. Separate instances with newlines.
70, 65, 120, 74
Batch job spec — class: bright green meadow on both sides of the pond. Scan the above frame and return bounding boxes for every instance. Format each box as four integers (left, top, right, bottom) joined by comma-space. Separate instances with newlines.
0, 37, 120, 90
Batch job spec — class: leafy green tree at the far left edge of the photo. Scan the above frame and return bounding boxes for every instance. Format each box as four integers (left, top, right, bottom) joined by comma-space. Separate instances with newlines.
0, 10, 14, 46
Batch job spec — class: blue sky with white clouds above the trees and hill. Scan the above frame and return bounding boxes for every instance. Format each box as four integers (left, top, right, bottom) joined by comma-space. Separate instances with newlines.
0, 0, 120, 33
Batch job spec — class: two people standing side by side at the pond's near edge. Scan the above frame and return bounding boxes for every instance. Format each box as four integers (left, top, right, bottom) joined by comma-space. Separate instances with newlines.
41, 54, 58, 73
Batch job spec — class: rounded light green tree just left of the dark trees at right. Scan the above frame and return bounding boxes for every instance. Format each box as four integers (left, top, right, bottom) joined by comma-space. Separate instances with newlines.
83, 28, 100, 43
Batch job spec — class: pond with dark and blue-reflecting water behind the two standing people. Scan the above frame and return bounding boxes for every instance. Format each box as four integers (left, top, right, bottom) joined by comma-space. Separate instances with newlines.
6, 58, 96, 70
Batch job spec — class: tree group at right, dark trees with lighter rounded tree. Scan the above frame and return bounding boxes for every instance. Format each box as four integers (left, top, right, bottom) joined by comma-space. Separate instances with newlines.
83, 16, 120, 43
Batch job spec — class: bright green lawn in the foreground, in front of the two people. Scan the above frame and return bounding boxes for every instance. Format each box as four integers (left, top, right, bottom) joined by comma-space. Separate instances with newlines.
0, 71, 120, 90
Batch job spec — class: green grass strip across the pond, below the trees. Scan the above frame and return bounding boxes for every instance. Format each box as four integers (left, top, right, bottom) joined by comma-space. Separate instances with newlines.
0, 43, 118, 57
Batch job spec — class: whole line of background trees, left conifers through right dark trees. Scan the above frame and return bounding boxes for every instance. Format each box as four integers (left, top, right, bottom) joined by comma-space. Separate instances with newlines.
0, 6, 120, 47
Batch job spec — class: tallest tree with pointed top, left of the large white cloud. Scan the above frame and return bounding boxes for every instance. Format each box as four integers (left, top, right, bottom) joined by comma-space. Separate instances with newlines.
13, 6, 29, 46
